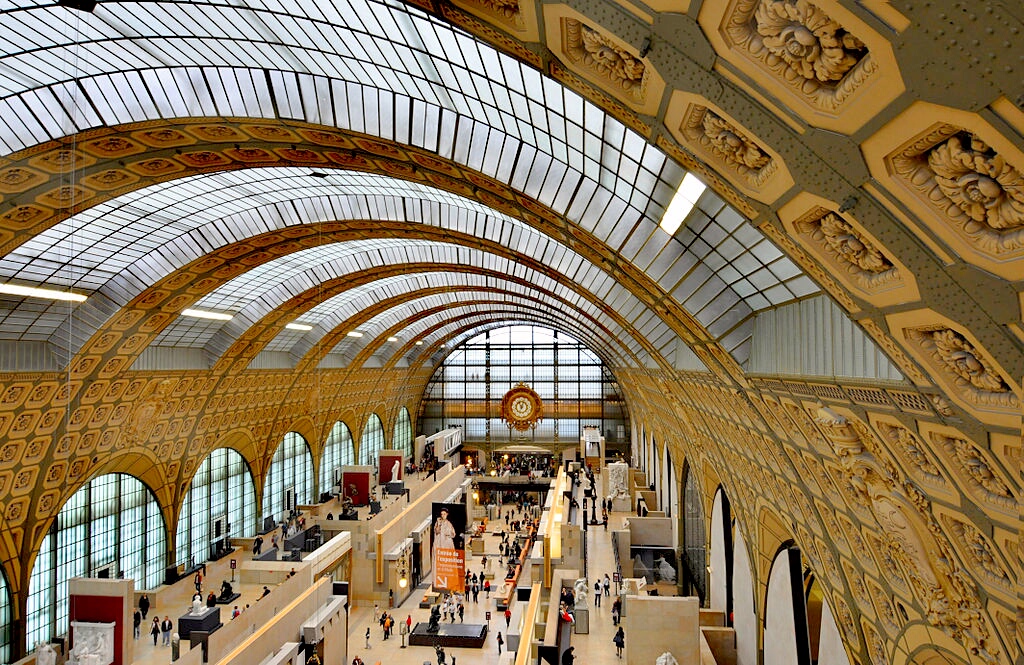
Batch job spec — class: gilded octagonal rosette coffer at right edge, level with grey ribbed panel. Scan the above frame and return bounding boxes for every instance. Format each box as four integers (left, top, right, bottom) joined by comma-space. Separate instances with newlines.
886, 309, 1021, 427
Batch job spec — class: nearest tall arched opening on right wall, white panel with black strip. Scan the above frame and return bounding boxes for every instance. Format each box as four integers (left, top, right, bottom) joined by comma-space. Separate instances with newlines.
764, 544, 811, 665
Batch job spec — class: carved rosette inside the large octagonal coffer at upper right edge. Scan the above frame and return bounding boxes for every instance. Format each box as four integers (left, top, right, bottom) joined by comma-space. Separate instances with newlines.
928, 135, 1024, 233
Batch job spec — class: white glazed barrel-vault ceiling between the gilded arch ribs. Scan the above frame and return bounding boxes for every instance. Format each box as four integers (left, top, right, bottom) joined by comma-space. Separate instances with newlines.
0, 0, 818, 363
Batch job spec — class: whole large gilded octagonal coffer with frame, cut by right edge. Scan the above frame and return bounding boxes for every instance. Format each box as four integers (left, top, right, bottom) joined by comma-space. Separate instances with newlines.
862, 101, 1024, 281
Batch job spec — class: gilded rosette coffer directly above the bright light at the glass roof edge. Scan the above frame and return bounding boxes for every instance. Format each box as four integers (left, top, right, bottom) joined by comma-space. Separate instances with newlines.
665, 90, 794, 204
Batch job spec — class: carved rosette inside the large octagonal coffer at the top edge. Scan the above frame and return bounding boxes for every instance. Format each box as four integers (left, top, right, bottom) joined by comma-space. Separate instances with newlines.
754, 0, 865, 83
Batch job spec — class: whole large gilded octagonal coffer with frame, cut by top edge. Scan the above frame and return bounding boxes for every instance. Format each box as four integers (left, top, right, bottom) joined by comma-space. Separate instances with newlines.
697, 0, 905, 134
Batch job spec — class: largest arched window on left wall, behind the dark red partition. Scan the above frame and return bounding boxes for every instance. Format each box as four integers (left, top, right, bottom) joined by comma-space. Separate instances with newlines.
26, 473, 167, 646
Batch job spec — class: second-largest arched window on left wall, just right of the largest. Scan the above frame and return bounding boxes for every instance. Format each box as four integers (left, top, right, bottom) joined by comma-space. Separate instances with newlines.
175, 448, 256, 568
